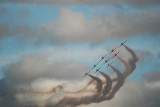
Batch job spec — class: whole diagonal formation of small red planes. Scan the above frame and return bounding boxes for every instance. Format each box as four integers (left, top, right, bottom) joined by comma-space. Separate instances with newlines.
83, 40, 127, 77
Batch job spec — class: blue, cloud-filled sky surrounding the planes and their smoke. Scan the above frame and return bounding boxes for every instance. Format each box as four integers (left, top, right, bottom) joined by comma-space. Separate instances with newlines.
0, 0, 160, 107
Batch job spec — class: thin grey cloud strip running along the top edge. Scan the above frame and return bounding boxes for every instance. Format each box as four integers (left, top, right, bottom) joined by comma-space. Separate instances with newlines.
0, 0, 160, 6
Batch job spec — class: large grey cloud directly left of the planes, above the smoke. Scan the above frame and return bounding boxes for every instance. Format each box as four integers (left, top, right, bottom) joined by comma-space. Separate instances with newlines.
3, 53, 88, 84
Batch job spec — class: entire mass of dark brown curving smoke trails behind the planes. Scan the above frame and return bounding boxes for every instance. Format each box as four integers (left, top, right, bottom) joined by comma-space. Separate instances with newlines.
49, 46, 138, 107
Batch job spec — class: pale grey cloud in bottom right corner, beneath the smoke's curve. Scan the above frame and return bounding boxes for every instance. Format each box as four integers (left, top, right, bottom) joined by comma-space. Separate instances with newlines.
87, 80, 160, 107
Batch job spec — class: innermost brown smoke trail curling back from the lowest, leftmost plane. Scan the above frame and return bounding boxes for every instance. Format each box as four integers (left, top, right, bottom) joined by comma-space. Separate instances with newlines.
54, 75, 102, 107
